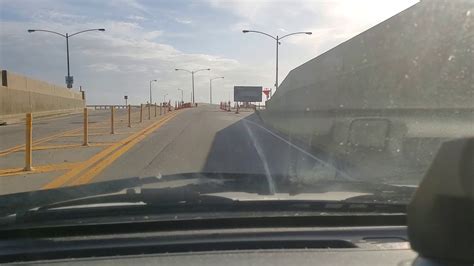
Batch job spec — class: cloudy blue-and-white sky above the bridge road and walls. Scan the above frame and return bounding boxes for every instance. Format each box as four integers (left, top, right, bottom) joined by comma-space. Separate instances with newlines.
0, 0, 418, 104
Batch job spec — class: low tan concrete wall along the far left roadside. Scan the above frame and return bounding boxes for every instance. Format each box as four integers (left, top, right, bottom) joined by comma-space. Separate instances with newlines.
0, 71, 85, 116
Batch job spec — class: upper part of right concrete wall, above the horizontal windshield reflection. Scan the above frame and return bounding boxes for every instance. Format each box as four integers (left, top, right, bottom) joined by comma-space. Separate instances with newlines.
267, 0, 474, 111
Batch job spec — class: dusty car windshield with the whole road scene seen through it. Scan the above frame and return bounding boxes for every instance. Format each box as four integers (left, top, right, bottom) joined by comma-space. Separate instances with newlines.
0, 0, 474, 218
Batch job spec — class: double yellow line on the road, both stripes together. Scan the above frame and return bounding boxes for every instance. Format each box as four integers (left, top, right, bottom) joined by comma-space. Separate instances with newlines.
42, 111, 181, 189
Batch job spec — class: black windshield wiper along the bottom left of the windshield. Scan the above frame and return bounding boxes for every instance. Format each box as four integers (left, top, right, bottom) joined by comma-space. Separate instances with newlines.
0, 173, 270, 217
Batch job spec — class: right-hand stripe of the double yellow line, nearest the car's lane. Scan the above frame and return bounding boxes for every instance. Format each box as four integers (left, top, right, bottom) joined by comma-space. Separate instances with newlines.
71, 115, 180, 185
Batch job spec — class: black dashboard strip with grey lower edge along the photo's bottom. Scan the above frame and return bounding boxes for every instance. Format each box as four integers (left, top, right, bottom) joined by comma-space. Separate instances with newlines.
0, 226, 417, 265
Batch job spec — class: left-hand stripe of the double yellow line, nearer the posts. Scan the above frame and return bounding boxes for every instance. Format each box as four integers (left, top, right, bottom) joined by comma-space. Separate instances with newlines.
42, 111, 181, 189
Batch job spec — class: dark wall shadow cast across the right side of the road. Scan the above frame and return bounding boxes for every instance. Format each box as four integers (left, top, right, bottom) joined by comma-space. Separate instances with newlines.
202, 114, 337, 183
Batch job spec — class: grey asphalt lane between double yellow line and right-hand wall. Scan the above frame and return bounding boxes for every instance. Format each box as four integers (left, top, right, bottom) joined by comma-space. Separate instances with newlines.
94, 105, 336, 184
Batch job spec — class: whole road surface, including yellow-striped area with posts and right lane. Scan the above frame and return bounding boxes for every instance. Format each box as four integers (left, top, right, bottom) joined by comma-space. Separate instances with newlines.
0, 104, 336, 194
